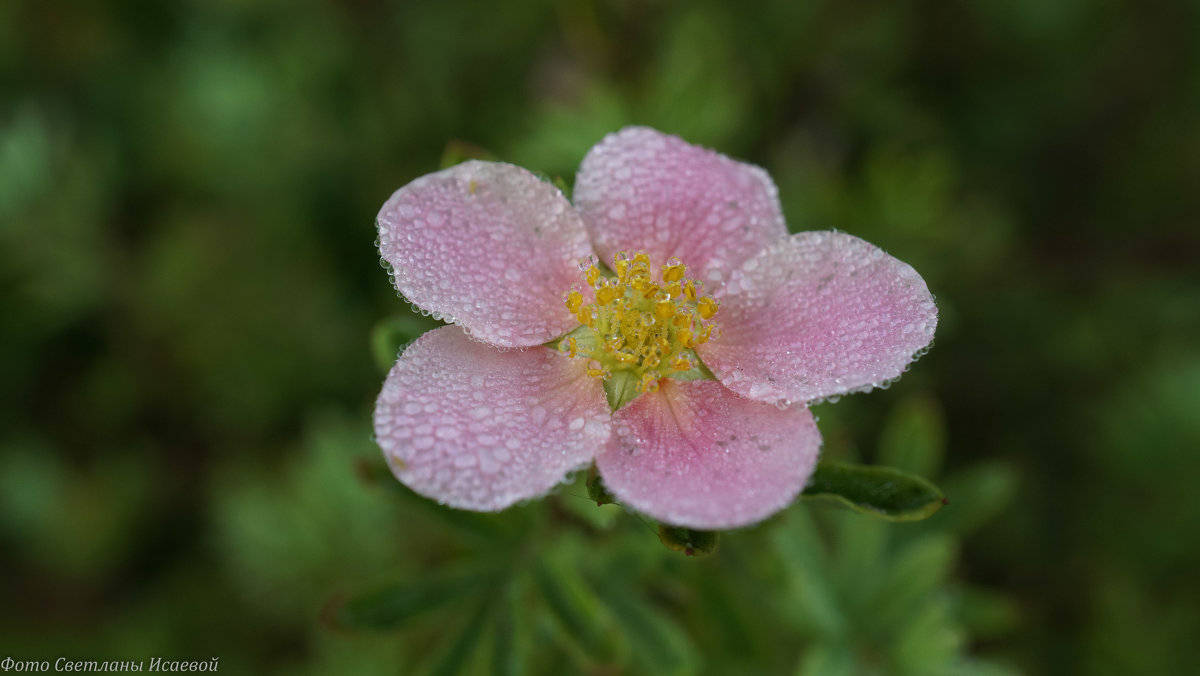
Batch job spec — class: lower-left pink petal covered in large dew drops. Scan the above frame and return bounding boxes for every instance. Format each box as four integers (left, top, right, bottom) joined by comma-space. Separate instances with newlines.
374, 327, 611, 512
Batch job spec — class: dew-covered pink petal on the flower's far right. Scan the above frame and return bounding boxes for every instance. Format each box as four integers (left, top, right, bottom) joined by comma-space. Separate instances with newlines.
697, 232, 937, 401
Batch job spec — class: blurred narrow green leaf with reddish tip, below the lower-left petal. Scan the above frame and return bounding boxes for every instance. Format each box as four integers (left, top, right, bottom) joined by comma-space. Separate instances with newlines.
324, 573, 494, 632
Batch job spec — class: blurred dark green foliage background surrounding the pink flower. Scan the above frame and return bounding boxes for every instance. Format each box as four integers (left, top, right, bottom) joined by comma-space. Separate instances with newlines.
0, 0, 1200, 675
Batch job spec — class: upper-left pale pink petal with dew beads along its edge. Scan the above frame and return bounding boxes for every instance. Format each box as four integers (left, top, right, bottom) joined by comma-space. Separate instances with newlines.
378, 161, 592, 347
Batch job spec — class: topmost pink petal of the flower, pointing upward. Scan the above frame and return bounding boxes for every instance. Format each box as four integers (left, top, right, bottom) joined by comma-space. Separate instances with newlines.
575, 127, 787, 282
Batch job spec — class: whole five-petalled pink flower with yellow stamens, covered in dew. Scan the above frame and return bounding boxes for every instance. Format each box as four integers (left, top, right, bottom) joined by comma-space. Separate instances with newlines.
374, 127, 937, 530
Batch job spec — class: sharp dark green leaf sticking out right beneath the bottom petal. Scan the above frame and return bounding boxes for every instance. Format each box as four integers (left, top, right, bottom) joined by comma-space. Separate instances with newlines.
802, 462, 946, 521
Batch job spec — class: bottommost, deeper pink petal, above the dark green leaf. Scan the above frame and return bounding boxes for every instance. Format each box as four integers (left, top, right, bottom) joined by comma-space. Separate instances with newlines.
596, 381, 821, 531
